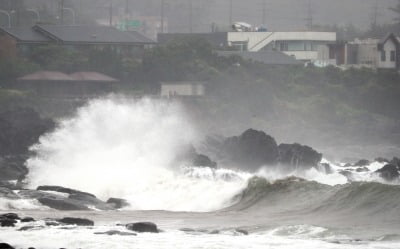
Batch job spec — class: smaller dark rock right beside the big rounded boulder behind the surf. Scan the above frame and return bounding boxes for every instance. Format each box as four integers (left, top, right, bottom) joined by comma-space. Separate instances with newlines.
279, 143, 322, 169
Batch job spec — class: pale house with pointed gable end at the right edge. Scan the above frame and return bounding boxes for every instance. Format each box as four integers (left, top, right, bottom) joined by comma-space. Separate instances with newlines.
316, 33, 400, 70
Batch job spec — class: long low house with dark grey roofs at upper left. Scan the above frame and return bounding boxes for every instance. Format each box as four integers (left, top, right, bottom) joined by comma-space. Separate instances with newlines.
0, 25, 155, 56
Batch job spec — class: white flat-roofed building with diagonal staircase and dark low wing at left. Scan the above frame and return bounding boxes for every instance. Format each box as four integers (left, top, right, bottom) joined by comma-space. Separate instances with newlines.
158, 31, 336, 61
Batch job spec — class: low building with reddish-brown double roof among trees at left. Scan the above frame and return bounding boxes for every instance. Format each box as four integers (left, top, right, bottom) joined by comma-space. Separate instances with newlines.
16, 71, 118, 96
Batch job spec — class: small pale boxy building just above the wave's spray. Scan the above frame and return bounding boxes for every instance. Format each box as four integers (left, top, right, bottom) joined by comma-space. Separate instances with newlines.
161, 81, 205, 98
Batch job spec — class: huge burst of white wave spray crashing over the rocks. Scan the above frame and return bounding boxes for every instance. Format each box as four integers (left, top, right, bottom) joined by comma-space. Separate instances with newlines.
27, 98, 247, 211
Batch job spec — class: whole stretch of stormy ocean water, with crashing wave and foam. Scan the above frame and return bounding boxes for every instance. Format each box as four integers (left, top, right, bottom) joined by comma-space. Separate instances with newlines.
0, 98, 400, 249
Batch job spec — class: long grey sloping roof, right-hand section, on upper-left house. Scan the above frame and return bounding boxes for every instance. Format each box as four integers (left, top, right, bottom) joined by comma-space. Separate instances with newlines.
34, 25, 154, 44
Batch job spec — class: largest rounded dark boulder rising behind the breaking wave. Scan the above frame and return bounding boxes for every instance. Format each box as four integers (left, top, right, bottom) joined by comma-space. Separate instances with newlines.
221, 129, 279, 171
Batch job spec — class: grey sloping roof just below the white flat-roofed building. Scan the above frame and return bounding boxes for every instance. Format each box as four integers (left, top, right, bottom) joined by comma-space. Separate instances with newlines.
217, 51, 303, 65
